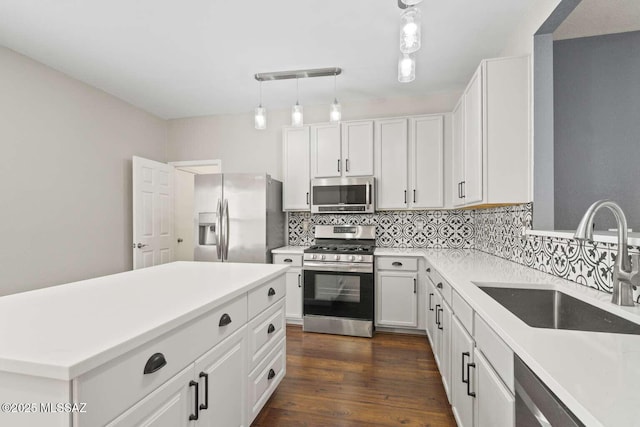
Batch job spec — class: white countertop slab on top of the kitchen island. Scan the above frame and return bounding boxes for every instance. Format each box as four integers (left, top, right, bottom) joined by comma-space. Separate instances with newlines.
0, 262, 287, 380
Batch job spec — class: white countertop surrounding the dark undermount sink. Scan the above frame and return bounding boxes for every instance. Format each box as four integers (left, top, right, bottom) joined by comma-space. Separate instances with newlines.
375, 248, 640, 427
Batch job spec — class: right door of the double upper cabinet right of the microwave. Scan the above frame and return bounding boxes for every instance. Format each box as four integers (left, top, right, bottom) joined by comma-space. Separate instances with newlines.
409, 116, 444, 209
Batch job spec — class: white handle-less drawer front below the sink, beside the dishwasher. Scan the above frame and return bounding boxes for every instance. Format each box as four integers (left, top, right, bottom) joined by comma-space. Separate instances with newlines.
474, 314, 515, 394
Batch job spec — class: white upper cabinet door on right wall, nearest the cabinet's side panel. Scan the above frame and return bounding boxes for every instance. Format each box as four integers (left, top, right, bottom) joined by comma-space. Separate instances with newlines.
462, 67, 483, 205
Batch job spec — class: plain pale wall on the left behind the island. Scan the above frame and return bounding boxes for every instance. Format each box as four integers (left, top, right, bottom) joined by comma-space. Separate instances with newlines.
0, 47, 167, 295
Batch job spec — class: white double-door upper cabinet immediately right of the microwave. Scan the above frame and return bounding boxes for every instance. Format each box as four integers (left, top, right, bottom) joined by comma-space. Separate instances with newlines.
375, 115, 444, 209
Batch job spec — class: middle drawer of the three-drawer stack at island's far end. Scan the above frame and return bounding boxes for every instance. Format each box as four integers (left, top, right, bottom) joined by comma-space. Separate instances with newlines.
249, 298, 285, 370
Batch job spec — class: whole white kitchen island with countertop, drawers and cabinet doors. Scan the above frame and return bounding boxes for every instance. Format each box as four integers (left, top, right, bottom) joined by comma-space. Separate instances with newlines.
0, 262, 286, 427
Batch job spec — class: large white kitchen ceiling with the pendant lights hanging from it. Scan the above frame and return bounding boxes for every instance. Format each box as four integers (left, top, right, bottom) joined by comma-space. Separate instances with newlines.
0, 0, 536, 118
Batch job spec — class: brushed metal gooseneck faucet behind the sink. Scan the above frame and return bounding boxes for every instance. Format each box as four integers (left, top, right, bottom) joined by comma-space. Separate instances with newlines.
574, 200, 640, 306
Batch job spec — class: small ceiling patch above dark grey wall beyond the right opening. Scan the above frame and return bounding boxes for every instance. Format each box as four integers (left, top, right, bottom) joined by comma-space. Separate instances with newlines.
553, 0, 640, 40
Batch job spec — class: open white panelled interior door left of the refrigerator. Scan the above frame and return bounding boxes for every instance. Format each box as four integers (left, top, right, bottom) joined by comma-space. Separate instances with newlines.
133, 156, 174, 269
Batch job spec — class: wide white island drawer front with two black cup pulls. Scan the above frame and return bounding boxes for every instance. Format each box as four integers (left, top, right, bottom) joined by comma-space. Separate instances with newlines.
73, 295, 247, 427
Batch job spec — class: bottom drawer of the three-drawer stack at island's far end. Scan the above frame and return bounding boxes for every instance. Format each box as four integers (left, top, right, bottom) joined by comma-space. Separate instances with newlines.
249, 338, 287, 424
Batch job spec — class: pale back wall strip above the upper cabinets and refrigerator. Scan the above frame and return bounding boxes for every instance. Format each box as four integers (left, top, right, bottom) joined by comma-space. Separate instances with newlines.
168, 92, 460, 179
